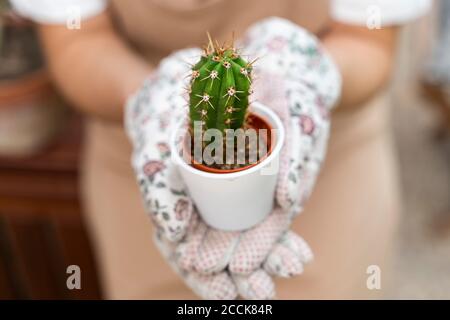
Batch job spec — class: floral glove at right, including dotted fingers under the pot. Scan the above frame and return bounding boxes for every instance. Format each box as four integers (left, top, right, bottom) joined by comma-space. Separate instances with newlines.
139, 19, 340, 299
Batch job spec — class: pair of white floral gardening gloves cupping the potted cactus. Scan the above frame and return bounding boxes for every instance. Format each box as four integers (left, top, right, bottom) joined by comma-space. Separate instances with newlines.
127, 19, 339, 299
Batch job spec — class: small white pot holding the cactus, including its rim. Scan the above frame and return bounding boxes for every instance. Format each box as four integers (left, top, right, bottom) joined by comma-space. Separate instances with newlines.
171, 102, 285, 231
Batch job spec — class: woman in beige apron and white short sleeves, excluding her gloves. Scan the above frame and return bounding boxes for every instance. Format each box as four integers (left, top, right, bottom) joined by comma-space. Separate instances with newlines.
13, 0, 429, 299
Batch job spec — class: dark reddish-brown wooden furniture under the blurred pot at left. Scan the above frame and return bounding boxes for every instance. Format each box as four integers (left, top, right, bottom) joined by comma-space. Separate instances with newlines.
0, 116, 101, 299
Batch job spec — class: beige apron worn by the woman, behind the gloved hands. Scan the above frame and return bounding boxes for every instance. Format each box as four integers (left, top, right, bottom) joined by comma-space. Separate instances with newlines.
79, 0, 399, 299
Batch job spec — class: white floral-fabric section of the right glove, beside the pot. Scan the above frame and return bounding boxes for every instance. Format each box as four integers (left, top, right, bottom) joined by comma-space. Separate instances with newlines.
243, 17, 341, 215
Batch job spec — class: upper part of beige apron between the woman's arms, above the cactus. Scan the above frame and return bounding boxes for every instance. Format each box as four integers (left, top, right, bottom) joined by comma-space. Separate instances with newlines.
111, 0, 328, 65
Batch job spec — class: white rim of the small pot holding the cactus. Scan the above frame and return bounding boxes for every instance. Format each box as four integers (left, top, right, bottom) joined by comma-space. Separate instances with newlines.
170, 102, 285, 180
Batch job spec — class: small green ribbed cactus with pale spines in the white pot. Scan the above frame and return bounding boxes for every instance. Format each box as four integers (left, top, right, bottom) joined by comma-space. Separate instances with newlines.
189, 35, 252, 132
